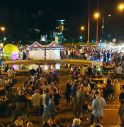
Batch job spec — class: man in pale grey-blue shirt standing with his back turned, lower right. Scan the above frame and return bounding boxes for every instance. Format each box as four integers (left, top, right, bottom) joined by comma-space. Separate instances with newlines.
91, 91, 106, 124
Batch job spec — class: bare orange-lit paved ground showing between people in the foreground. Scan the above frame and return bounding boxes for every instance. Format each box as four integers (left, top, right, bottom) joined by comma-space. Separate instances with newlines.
0, 75, 124, 127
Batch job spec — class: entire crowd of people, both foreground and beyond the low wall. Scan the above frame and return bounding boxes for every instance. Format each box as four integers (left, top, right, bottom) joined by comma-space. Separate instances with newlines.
0, 44, 124, 127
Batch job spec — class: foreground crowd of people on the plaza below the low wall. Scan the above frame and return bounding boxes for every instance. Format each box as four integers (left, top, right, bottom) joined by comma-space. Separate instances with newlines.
1, 61, 120, 127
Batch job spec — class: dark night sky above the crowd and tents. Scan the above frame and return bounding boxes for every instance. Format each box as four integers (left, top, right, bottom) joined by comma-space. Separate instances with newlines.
0, 0, 124, 40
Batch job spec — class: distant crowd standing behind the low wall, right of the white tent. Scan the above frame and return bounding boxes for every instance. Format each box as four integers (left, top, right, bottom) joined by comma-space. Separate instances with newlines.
61, 46, 124, 64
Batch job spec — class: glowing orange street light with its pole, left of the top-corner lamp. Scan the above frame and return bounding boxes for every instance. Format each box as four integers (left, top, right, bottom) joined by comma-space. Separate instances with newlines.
94, 12, 100, 47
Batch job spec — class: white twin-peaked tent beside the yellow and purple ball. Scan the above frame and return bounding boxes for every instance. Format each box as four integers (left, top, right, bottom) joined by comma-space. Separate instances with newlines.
27, 42, 62, 60
